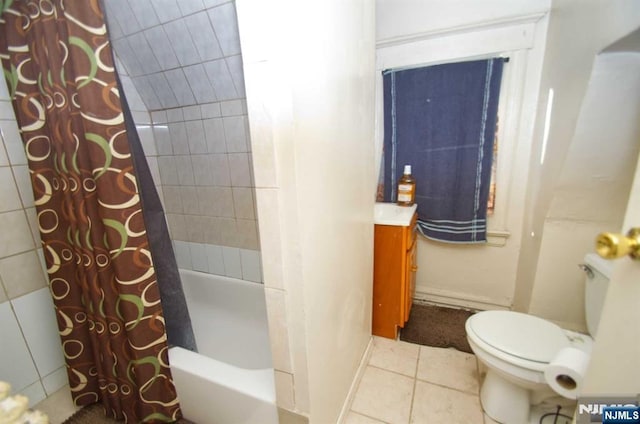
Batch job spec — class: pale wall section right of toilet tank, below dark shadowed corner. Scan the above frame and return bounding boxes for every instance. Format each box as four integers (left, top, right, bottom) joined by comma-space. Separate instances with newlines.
530, 49, 640, 325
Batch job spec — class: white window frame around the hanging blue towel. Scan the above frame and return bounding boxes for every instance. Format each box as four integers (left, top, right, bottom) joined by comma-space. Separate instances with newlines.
375, 17, 538, 246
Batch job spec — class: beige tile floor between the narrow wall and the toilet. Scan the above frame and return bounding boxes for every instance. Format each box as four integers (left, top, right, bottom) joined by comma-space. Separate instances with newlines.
345, 337, 494, 424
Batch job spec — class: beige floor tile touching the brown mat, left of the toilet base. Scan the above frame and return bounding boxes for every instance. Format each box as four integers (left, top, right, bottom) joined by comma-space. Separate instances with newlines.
417, 346, 478, 395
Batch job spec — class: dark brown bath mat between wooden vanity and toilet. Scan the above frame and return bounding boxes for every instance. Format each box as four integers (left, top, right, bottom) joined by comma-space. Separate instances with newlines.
400, 303, 473, 353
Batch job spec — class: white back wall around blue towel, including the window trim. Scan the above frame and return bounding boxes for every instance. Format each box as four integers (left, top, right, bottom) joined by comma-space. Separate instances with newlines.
376, 0, 549, 309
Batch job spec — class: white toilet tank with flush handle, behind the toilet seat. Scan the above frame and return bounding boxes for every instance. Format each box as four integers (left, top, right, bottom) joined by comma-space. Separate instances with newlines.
584, 253, 613, 338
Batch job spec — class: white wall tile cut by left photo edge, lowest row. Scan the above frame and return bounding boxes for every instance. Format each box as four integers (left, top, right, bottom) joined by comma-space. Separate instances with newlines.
0, 302, 38, 392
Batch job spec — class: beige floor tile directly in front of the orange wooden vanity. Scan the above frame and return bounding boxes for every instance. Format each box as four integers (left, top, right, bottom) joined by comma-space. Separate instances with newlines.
369, 337, 420, 377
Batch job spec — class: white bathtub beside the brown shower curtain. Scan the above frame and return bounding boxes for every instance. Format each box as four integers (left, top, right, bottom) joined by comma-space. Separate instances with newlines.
169, 269, 278, 424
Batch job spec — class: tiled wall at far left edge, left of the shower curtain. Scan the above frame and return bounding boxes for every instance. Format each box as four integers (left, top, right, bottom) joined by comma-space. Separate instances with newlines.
0, 81, 67, 406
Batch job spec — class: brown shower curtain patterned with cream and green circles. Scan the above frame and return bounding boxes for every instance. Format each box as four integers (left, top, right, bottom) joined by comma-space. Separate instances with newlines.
0, 0, 180, 422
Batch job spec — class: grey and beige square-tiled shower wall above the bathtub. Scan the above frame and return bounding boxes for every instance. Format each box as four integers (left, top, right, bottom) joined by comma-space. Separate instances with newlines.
106, 0, 262, 282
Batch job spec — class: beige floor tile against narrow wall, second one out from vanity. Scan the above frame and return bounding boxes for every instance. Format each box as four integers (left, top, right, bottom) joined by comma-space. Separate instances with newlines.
351, 366, 414, 424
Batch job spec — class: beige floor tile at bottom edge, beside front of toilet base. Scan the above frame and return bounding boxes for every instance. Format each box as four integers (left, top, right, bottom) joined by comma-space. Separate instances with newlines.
411, 381, 483, 424
